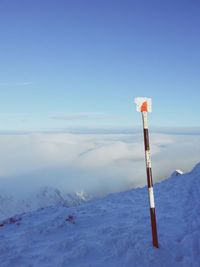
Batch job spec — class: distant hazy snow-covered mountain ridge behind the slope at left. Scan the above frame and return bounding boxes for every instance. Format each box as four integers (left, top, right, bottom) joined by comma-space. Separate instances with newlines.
0, 186, 90, 219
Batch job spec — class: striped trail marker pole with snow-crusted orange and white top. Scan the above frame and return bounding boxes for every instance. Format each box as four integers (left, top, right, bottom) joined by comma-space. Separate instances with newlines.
135, 97, 159, 248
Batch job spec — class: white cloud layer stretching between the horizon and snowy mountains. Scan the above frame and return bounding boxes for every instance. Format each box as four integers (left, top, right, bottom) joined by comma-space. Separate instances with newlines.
0, 134, 200, 199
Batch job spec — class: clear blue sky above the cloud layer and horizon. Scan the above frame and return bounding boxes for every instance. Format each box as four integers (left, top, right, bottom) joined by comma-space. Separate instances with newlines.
0, 0, 200, 131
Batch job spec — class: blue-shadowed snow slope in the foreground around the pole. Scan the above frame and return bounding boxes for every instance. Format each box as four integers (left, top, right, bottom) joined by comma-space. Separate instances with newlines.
0, 164, 200, 267
